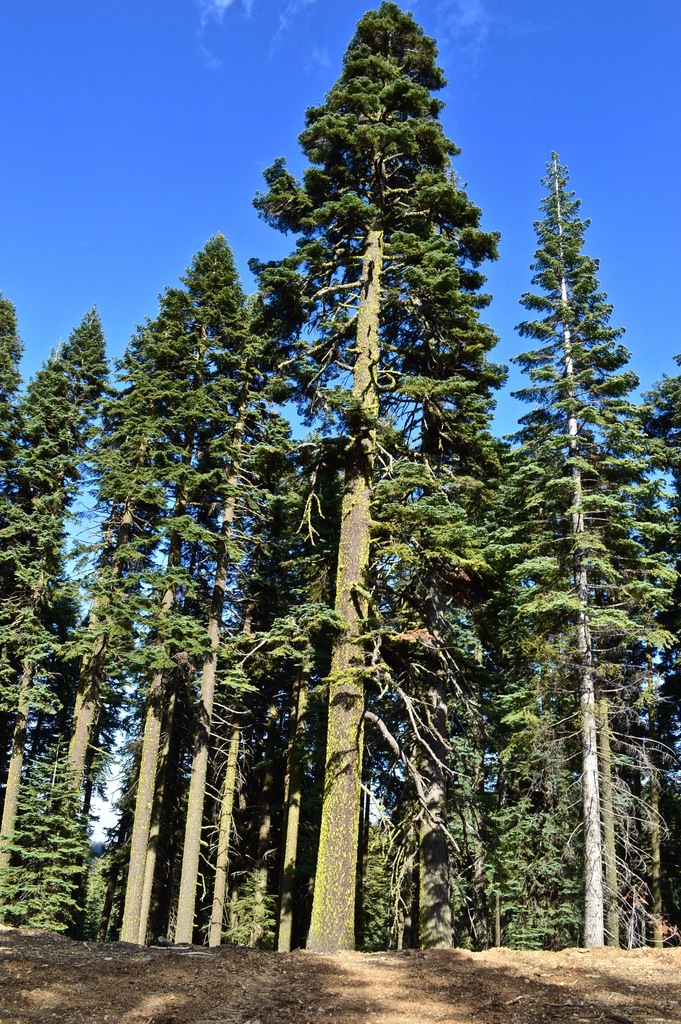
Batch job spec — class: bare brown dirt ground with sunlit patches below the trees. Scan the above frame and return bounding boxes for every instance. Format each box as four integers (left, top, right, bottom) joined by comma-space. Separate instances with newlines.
0, 929, 681, 1024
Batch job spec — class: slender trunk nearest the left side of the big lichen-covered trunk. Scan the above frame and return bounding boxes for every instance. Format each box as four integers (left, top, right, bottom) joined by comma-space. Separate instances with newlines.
276, 668, 308, 953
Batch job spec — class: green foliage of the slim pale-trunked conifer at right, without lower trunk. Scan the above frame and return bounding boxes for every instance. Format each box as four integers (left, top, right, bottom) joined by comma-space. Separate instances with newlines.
504, 155, 675, 647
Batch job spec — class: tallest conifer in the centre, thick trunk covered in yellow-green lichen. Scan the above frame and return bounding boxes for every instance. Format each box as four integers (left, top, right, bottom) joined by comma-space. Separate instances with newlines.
256, 2, 496, 950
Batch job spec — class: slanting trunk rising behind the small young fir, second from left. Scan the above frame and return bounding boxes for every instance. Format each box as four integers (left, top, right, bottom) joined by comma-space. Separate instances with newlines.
69, 499, 134, 790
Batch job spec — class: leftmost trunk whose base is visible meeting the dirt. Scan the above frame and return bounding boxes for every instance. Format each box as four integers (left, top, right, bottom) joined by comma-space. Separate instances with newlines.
121, 520, 184, 943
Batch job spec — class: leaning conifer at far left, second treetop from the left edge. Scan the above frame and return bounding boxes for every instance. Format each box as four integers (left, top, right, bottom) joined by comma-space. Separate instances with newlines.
0, 309, 108, 866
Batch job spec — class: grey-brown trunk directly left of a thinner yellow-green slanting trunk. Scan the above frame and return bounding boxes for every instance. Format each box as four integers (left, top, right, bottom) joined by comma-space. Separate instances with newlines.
175, 479, 239, 942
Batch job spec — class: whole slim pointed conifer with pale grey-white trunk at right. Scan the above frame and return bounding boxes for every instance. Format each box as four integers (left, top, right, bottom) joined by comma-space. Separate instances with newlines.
506, 155, 673, 946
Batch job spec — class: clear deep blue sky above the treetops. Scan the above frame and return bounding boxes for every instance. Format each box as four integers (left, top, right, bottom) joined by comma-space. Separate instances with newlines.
0, 0, 681, 431
